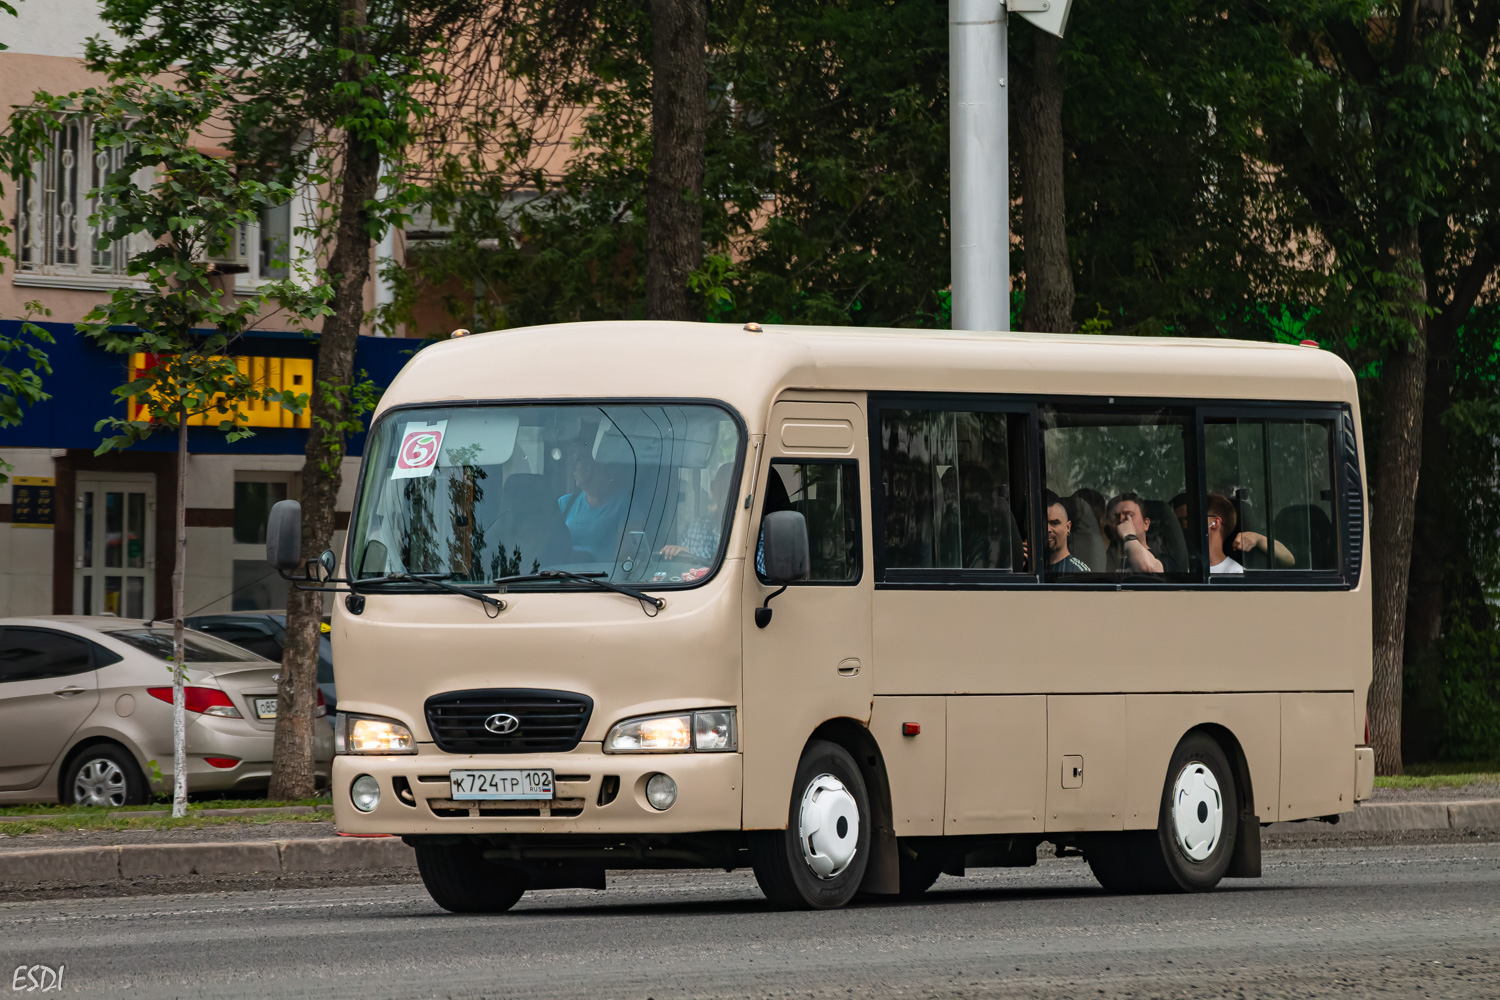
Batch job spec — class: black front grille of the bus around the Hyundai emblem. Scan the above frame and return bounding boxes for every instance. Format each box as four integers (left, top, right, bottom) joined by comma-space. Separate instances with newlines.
426, 688, 594, 754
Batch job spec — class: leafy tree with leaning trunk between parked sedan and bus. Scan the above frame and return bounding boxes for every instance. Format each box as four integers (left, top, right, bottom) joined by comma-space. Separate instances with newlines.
89, 0, 491, 799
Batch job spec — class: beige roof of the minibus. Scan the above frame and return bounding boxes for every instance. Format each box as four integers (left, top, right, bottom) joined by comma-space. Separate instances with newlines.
381, 321, 1356, 429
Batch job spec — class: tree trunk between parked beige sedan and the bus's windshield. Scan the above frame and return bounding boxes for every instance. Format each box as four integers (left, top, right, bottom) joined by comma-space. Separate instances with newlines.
267, 0, 380, 799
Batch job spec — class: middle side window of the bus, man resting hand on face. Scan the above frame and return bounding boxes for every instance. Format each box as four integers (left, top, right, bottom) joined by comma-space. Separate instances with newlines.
1040, 405, 1202, 582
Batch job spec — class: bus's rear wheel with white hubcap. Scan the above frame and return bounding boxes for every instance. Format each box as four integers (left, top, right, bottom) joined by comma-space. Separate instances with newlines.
1085, 733, 1239, 892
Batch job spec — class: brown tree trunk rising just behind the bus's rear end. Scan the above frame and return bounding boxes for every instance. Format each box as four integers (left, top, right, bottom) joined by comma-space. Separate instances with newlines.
1368, 228, 1427, 774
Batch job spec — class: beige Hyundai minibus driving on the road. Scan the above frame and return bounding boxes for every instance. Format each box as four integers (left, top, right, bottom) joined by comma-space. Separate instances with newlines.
269, 322, 1374, 912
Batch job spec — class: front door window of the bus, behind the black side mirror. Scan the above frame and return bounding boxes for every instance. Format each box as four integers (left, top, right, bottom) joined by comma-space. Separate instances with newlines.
756, 460, 860, 583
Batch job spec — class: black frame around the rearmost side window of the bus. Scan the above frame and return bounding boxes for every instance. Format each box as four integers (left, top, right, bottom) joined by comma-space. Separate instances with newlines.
1199, 400, 1359, 591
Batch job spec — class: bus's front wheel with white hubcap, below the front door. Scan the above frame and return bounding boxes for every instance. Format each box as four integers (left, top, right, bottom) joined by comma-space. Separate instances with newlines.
750, 739, 870, 910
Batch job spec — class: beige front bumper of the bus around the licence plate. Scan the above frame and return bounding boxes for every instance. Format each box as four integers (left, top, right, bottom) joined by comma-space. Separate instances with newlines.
333, 744, 743, 834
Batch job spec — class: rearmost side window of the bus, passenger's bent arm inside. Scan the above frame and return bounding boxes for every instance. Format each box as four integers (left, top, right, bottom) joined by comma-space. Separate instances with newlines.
1203, 417, 1338, 574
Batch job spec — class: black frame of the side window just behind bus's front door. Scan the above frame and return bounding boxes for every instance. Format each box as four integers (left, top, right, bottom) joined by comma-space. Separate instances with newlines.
869, 393, 1043, 589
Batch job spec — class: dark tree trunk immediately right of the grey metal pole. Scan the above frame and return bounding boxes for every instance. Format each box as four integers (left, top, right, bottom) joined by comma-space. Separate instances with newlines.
1011, 31, 1074, 333
